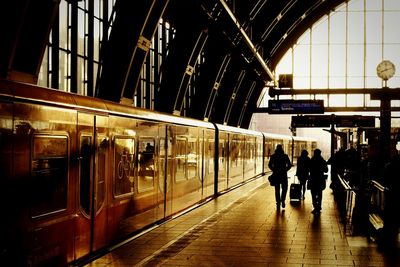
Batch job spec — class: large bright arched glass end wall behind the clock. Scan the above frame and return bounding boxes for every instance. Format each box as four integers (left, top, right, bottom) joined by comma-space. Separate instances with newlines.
261, 0, 400, 110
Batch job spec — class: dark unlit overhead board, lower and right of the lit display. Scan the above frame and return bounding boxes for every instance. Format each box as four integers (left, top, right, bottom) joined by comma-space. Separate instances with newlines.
291, 115, 375, 128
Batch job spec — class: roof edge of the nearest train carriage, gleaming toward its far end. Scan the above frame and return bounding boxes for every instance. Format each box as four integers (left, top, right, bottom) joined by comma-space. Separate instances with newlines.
0, 80, 215, 129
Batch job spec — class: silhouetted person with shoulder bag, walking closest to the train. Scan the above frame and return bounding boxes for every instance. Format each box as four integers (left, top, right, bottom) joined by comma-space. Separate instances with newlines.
268, 145, 292, 209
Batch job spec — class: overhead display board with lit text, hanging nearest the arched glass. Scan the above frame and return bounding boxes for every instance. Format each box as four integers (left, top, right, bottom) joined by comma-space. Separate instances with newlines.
268, 99, 324, 114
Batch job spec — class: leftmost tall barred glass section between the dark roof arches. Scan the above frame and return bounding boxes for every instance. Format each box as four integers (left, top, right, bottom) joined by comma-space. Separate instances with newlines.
38, 0, 116, 96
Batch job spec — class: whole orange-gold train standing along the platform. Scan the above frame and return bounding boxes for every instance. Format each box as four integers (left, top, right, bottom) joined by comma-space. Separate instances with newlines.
0, 80, 317, 266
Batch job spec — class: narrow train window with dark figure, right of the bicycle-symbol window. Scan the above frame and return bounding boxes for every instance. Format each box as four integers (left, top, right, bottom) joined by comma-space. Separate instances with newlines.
138, 138, 155, 193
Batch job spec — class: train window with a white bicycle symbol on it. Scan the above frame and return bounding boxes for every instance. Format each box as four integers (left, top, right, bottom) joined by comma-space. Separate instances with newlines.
113, 136, 135, 197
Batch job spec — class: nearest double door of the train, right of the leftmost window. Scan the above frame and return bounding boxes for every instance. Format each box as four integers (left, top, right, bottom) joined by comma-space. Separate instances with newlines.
75, 113, 109, 258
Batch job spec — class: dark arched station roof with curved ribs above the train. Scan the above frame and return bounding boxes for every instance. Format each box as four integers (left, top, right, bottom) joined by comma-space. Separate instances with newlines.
0, 0, 345, 128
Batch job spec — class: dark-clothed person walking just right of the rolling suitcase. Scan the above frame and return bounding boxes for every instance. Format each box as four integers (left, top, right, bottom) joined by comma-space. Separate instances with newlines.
307, 148, 328, 215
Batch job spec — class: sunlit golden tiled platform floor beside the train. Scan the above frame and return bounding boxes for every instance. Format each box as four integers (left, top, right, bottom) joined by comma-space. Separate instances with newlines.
86, 177, 400, 267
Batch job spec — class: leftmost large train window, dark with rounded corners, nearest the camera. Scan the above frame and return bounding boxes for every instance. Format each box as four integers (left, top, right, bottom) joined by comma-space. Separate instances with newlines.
29, 134, 68, 218
